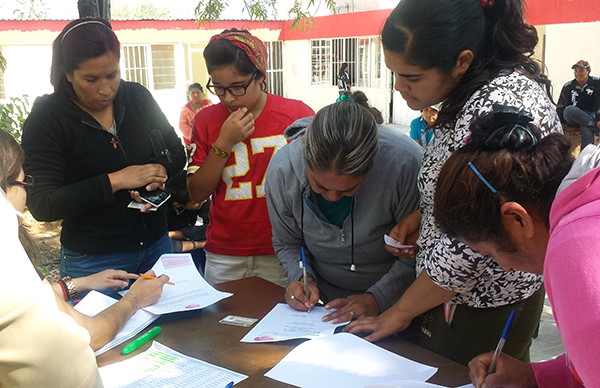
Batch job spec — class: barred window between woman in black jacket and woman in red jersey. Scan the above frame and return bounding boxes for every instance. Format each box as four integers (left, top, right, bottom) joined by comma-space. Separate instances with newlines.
123, 44, 176, 90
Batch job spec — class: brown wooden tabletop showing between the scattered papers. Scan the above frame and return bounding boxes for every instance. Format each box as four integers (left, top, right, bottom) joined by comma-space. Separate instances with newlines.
97, 277, 470, 388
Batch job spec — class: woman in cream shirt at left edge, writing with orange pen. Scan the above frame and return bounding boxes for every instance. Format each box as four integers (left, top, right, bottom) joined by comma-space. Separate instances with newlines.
0, 131, 169, 387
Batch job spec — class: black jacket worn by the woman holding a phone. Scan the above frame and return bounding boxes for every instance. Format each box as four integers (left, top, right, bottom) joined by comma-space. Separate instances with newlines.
22, 81, 185, 254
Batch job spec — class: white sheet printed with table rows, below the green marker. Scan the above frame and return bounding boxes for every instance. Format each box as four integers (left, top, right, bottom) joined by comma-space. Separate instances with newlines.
99, 341, 248, 388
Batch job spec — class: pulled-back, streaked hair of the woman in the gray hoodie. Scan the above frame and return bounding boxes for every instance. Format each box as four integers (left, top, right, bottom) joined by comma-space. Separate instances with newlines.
304, 100, 379, 176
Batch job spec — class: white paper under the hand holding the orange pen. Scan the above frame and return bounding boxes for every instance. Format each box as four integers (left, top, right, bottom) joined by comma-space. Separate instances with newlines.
123, 253, 233, 314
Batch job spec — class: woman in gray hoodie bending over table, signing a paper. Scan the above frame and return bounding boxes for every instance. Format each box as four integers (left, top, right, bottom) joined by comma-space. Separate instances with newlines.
266, 95, 422, 323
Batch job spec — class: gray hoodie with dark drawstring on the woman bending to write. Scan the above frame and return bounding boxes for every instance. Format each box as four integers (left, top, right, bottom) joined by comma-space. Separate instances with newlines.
265, 123, 422, 312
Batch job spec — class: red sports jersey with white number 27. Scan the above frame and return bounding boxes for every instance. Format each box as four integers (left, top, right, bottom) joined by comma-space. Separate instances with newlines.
188, 94, 315, 256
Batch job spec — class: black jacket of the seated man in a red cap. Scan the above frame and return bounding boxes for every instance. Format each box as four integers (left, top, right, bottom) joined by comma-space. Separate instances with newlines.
556, 76, 600, 123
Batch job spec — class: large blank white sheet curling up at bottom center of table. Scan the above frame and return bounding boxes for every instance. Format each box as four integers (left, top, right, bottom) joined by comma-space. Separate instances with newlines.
265, 333, 437, 388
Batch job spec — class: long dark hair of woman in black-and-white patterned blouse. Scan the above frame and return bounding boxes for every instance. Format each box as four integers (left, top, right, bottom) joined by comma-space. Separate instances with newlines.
381, 0, 549, 129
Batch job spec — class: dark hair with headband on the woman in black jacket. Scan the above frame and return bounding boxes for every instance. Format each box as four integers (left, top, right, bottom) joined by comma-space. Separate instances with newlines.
50, 18, 121, 98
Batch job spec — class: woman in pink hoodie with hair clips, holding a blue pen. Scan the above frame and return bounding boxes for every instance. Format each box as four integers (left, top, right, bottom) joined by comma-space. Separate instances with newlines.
434, 110, 600, 388
